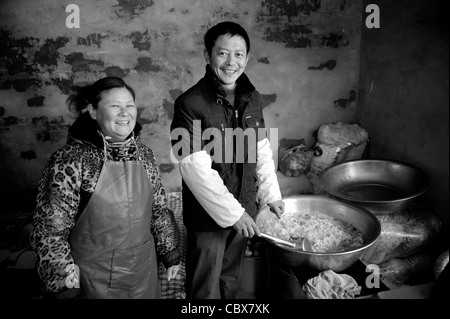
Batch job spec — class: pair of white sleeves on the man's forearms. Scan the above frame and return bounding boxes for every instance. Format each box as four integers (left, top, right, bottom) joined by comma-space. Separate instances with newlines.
179, 138, 281, 228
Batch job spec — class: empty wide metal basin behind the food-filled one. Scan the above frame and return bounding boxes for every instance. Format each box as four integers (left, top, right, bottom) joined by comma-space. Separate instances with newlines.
319, 160, 429, 214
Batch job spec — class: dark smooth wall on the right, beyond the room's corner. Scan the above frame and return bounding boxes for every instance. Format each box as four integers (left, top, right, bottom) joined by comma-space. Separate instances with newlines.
357, 0, 449, 244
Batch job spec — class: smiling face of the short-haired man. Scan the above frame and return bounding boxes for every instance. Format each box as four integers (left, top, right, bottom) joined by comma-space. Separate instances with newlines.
204, 34, 250, 89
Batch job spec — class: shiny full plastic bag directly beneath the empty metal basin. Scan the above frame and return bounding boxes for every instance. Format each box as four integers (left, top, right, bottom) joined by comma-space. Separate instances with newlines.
362, 204, 441, 264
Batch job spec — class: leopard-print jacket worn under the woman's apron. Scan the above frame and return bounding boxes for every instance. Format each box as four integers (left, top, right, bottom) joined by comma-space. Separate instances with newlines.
31, 115, 180, 293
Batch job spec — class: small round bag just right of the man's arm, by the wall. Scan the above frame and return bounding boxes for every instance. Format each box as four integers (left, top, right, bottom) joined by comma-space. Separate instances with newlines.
278, 139, 313, 177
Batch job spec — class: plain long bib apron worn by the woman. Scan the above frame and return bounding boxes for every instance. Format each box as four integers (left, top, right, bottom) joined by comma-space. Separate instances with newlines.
70, 141, 161, 299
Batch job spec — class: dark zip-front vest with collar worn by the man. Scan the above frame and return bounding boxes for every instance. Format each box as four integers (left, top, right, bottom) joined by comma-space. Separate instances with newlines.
171, 66, 266, 231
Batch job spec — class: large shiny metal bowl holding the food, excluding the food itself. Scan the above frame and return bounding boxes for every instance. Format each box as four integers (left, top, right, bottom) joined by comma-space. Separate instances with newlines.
255, 195, 381, 272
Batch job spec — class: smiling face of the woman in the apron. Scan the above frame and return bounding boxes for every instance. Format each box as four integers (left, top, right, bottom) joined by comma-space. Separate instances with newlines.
88, 88, 137, 141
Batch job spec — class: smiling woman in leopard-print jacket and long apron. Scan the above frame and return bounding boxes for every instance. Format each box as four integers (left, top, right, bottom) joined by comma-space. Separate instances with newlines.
31, 77, 180, 298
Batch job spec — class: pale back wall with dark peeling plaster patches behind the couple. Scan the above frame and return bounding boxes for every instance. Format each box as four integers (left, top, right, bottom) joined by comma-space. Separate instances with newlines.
0, 0, 362, 215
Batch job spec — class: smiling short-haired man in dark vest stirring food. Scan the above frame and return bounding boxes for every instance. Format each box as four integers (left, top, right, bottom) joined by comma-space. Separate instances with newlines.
171, 22, 284, 299
